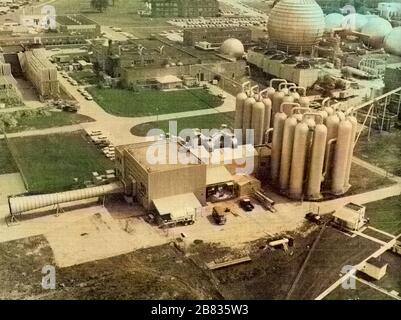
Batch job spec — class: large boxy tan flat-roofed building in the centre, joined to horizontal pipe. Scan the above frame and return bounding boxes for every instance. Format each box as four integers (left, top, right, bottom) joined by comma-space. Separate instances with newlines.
116, 140, 258, 210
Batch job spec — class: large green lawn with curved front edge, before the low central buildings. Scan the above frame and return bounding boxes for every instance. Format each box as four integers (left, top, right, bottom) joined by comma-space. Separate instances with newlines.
88, 87, 223, 117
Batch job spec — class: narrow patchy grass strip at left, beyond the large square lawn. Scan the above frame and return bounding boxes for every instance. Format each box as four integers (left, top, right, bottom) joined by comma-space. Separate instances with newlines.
6, 111, 93, 133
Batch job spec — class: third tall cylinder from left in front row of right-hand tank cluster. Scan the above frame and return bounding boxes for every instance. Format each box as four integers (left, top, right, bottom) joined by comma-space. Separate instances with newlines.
288, 122, 309, 200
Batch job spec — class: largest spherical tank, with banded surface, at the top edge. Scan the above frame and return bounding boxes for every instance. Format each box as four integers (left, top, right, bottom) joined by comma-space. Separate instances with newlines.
268, 0, 325, 53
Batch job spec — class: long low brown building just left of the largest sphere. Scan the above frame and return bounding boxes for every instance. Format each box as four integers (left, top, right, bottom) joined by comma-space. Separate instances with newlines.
184, 27, 252, 47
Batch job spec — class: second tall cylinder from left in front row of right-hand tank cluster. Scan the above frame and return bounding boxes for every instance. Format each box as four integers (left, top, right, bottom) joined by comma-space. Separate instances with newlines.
279, 116, 298, 192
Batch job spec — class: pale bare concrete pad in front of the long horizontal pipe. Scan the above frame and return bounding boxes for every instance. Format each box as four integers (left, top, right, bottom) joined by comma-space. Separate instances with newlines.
44, 211, 166, 268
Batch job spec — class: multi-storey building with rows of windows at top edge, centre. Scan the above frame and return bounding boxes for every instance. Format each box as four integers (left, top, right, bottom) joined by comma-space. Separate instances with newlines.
149, 0, 219, 18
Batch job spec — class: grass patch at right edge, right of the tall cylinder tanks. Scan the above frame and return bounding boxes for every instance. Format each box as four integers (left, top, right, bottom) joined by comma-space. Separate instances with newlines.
355, 130, 401, 176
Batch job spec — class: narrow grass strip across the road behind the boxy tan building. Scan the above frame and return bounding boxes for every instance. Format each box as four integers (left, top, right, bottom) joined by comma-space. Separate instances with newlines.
131, 112, 235, 137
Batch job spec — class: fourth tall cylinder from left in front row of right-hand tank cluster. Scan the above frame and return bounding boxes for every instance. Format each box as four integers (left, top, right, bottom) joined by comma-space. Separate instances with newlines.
306, 124, 327, 200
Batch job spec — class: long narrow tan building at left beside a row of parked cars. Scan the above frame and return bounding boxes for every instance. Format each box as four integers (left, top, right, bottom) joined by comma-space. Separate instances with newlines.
18, 49, 59, 99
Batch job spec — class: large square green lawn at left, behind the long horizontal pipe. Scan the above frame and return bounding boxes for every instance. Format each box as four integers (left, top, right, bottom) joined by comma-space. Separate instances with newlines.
10, 131, 113, 193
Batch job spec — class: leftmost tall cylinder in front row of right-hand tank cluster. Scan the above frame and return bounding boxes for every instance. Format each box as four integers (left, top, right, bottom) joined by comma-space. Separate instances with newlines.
270, 112, 287, 183
